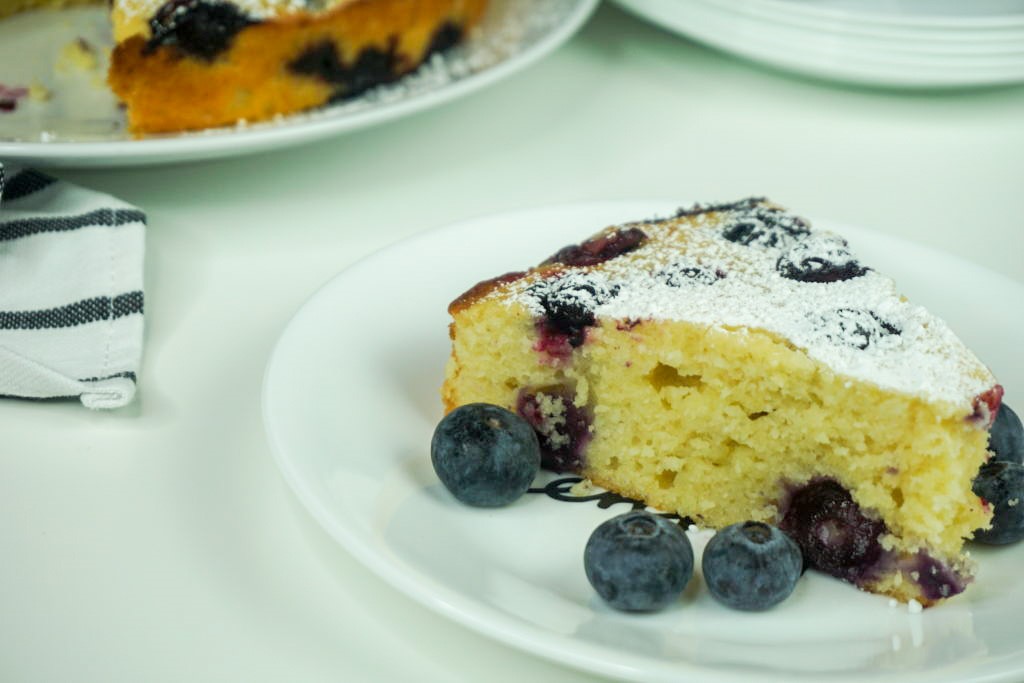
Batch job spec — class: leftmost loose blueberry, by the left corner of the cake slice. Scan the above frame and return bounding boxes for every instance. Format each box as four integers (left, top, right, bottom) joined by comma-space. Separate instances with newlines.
430, 403, 541, 508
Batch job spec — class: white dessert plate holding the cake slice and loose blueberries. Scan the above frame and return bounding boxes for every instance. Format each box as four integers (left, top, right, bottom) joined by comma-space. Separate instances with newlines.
263, 202, 1024, 683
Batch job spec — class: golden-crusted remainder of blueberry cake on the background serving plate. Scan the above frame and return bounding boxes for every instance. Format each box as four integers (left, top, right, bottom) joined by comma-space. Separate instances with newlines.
0, 0, 486, 134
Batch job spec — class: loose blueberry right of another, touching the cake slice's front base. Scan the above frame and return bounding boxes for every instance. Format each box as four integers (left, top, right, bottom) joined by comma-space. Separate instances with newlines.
700, 521, 804, 611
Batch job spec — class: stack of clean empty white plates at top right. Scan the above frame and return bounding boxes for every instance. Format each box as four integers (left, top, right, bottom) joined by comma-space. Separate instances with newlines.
617, 0, 1024, 88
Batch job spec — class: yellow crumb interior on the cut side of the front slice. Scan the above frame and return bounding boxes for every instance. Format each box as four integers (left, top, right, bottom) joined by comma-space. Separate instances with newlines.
445, 300, 987, 558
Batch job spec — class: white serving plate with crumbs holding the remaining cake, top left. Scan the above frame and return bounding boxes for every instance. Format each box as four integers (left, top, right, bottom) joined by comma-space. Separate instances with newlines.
0, 0, 597, 167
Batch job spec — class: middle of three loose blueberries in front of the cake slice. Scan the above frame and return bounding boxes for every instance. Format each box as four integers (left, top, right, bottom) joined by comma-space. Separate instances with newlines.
583, 510, 693, 611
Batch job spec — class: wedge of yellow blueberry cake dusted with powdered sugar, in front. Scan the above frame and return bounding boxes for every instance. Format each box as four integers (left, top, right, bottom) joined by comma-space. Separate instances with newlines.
442, 199, 1002, 605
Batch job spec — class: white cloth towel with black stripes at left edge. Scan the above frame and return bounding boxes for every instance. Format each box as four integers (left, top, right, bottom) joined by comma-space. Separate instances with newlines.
0, 164, 145, 409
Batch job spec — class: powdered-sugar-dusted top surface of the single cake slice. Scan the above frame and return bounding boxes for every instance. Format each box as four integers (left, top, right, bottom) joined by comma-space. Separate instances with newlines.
475, 199, 995, 405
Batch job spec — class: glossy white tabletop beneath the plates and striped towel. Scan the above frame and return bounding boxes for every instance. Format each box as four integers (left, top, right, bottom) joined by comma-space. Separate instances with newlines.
0, 7, 1024, 683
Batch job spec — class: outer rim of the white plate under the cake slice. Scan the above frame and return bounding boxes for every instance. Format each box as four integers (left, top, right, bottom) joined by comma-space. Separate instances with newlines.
260, 199, 1024, 683
